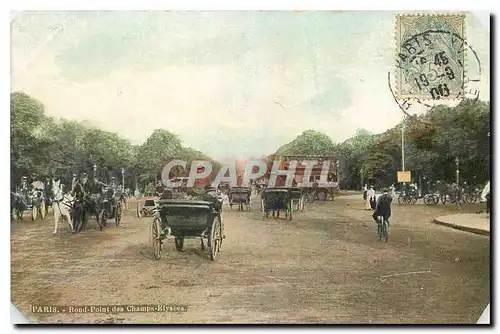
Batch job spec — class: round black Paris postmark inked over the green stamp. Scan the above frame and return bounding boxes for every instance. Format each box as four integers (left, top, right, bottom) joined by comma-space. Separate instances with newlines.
388, 29, 481, 117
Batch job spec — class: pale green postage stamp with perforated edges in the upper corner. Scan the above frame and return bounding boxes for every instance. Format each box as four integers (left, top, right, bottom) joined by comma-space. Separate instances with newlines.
395, 14, 467, 100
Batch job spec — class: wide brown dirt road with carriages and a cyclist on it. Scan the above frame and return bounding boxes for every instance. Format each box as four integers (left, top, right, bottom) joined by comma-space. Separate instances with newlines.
11, 196, 490, 323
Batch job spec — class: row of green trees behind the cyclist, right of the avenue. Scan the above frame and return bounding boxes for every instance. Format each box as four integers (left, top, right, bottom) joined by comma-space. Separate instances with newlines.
275, 100, 491, 189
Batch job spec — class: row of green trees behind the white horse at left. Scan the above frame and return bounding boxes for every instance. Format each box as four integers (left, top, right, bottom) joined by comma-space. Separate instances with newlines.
10, 92, 218, 187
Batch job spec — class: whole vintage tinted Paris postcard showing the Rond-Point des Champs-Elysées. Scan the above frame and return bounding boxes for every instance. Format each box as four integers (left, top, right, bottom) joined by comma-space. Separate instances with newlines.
10, 11, 492, 324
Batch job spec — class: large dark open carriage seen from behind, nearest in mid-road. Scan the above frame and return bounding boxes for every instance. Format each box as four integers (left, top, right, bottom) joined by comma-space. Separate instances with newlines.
151, 199, 225, 260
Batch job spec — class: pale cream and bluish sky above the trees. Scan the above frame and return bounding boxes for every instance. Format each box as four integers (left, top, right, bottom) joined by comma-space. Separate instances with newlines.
11, 11, 490, 160
